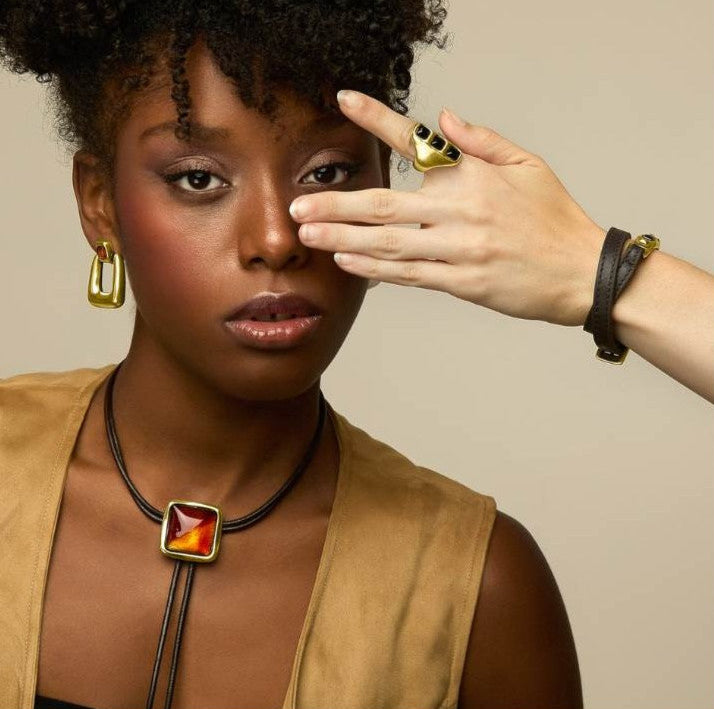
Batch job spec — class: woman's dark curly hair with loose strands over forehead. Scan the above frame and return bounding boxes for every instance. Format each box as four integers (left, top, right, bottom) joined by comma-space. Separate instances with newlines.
0, 0, 448, 169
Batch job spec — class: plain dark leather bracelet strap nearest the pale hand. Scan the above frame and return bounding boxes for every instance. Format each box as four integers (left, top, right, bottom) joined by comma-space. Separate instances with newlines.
583, 227, 628, 353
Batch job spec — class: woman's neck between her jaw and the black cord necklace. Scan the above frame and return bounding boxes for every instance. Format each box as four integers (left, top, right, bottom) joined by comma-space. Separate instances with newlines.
107, 326, 325, 516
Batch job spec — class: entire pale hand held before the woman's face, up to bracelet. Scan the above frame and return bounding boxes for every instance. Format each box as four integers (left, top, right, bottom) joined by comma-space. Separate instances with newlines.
291, 91, 605, 325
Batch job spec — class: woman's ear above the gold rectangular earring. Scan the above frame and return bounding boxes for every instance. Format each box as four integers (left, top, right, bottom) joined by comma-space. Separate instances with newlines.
72, 150, 121, 253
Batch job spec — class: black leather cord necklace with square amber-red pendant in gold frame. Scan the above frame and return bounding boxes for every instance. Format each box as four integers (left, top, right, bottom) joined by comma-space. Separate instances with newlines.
104, 364, 326, 709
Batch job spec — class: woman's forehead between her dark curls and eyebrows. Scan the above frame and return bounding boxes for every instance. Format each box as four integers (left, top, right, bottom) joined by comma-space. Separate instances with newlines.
118, 42, 364, 146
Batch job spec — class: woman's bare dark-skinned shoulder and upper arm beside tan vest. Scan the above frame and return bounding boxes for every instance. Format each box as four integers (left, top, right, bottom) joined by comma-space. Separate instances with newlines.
459, 512, 583, 709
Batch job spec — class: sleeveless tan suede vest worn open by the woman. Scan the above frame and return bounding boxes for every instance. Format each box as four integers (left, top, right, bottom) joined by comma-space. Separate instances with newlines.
0, 365, 496, 709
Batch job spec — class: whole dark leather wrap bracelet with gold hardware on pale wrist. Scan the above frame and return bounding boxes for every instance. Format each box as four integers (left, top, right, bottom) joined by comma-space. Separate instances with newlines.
583, 227, 659, 364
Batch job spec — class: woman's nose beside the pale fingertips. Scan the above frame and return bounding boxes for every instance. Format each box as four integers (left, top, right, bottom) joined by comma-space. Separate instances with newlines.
237, 183, 310, 271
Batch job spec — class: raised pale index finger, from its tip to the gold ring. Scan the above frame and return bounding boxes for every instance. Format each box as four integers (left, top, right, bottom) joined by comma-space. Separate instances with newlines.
337, 89, 416, 160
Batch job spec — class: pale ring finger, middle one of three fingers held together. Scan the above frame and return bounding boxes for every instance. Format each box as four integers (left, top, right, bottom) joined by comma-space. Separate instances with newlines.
298, 222, 460, 263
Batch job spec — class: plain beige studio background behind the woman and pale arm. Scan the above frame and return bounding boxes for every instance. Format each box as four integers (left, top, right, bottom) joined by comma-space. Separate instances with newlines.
0, 0, 714, 709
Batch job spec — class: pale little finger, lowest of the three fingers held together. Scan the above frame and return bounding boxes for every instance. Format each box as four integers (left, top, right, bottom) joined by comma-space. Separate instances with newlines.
334, 253, 454, 291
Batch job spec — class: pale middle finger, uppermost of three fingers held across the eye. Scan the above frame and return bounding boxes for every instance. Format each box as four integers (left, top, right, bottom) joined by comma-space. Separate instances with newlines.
290, 187, 444, 224
